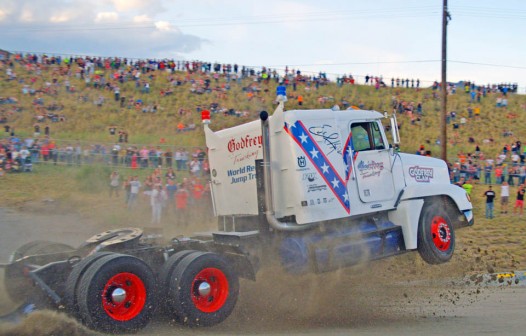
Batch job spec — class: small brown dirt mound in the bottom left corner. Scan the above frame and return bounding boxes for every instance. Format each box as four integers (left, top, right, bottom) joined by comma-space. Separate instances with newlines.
0, 310, 100, 336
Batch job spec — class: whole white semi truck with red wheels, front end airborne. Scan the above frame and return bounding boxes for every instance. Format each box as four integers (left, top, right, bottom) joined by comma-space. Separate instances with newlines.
0, 102, 473, 333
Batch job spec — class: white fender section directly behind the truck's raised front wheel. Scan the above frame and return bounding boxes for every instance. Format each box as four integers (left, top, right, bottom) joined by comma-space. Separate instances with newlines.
388, 198, 424, 250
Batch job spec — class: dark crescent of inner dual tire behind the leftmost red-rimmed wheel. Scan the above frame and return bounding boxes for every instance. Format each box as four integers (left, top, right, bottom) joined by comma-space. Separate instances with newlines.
62, 252, 112, 318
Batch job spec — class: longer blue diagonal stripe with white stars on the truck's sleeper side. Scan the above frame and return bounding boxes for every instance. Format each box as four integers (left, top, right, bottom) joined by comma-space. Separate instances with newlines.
283, 120, 351, 213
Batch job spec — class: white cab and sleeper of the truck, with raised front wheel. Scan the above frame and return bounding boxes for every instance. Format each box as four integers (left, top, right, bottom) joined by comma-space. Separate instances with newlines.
205, 102, 473, 272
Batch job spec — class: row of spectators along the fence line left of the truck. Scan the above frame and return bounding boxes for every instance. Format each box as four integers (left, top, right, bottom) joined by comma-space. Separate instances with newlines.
0, 126, 209, 176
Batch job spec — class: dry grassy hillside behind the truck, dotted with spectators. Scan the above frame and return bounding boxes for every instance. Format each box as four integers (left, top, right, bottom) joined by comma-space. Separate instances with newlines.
0, 57, 526, 161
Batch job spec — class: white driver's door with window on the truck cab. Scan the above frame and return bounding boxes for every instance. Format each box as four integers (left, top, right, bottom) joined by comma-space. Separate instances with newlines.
349, 121, 395, 203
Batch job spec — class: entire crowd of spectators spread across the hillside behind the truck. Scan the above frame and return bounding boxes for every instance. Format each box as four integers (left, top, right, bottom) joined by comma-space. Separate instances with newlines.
0, 53, 526, 222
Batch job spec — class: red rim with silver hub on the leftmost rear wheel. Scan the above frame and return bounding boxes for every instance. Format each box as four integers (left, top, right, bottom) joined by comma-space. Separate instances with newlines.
102, 273, 146, 321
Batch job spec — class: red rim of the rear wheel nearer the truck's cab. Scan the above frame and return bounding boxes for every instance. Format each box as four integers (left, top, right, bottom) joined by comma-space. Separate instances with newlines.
192, 268, 228, 313
